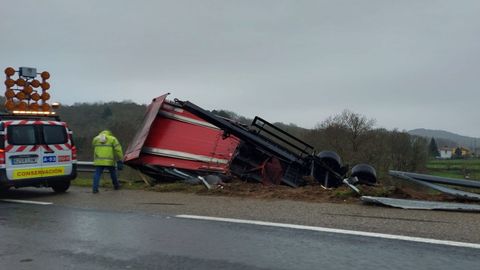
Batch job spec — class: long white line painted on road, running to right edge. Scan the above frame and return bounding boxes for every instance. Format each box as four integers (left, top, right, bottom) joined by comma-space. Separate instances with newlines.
176, 215, 480, 249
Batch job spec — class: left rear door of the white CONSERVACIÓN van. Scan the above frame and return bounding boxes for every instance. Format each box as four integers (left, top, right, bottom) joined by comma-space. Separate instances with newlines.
5, 121, 43, 181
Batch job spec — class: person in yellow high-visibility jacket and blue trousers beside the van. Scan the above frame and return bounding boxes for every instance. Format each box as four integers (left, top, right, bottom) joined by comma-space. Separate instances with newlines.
92, 130, 123, 193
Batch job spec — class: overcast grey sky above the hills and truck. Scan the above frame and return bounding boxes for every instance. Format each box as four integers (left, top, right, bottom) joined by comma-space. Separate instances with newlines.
0, 0, 480, 137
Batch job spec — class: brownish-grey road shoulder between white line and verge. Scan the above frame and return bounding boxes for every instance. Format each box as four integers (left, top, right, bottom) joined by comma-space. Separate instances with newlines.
0, 187, 480, 243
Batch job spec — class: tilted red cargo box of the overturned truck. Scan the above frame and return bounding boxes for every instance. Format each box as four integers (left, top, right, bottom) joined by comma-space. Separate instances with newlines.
124, 94, 240, 178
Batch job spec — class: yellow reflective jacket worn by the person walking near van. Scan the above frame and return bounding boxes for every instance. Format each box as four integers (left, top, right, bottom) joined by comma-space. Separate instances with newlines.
92, 130, 123, 166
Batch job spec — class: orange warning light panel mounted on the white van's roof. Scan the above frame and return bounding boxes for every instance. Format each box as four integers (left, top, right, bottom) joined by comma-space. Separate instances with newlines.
5, 67, 58, 115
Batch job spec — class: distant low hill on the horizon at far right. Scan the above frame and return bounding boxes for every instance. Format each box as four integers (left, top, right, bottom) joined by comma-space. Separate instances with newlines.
408, 128, 480, 149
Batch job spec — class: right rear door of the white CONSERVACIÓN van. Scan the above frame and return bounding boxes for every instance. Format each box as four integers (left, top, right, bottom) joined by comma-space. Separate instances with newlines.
40, 121, 72, 176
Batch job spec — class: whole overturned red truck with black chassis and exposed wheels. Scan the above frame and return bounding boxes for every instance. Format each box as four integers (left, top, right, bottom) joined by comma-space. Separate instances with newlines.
124, 94, 376, 188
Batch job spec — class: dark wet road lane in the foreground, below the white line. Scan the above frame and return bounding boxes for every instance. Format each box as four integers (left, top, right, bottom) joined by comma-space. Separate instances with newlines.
0, 199, 480, 269
